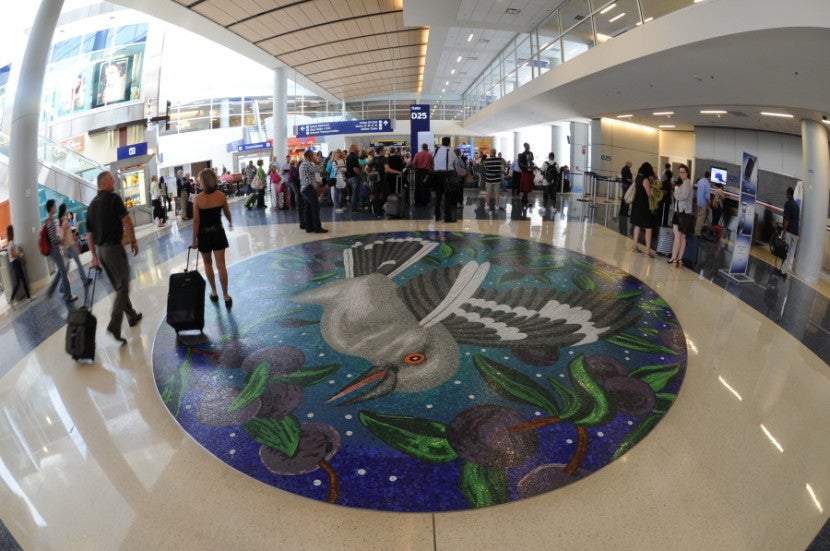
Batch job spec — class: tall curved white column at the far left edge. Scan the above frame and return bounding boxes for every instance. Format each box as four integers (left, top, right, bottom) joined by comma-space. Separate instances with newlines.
9, 0, 63, 284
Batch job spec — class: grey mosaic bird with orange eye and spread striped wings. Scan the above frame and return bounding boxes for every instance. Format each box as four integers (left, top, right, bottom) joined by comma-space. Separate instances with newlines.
294, 237, 639, 404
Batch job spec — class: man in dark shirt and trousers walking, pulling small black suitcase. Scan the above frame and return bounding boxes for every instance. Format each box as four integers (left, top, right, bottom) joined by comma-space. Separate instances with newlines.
86, 172, 143, 345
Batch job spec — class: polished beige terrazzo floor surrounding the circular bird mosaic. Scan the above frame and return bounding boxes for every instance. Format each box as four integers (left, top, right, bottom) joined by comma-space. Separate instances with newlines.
0, 192, 830, 550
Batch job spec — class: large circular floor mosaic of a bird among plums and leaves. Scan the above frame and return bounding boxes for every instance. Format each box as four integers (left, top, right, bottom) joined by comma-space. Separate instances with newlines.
153, 232, 686, 512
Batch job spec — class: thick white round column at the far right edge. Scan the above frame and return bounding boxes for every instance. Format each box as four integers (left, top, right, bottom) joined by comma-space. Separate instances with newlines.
795, 119, 830, 283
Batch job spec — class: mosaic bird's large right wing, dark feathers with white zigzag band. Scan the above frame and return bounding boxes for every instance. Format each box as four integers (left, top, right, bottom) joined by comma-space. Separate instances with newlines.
441, 287, 640, 348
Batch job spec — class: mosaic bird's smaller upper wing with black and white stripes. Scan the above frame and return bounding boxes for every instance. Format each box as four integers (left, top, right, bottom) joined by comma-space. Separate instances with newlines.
343, 237, 438, 278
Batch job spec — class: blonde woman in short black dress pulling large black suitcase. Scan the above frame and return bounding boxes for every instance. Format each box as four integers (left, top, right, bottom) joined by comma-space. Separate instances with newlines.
191, 168, 233, 309
